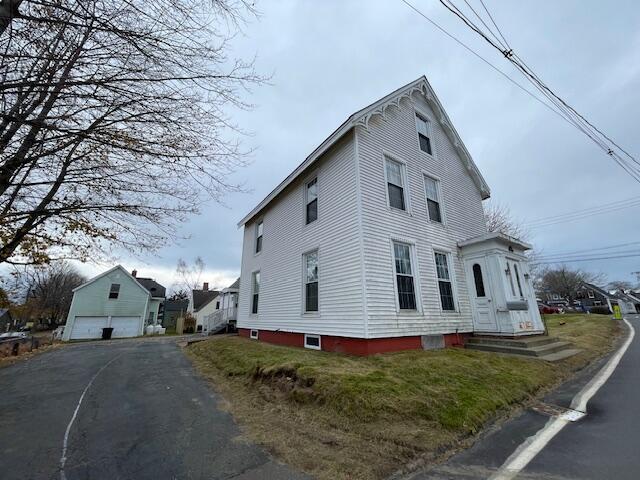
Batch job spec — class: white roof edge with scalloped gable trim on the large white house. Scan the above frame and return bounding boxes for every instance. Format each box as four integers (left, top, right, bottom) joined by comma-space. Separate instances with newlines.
238, 75, 490, 227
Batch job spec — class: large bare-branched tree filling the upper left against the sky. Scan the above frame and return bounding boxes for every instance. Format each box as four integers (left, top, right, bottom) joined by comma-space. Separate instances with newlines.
0, 0, 263, 264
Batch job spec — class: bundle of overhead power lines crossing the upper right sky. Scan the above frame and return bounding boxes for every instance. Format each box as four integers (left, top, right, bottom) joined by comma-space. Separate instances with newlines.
438, 0, 640, 183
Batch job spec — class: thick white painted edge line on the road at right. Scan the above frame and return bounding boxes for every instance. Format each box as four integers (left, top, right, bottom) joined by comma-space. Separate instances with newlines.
489, 318, 636, 480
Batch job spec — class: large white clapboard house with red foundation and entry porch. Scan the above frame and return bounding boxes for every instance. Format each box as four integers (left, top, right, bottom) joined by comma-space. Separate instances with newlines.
238, 77, 544, 354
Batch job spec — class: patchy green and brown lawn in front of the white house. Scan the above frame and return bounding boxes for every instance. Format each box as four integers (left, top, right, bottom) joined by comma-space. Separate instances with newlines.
188, 315, 619, 479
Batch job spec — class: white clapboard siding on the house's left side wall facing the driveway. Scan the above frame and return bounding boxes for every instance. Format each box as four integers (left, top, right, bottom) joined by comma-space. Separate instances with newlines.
238, 132, 364, 337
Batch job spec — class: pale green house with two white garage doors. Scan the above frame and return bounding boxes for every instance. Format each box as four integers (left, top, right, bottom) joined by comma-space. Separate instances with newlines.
63, 265, 165, 340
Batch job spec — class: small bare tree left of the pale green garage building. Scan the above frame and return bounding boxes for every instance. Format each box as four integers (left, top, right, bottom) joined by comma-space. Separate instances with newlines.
14, 261, 87, 325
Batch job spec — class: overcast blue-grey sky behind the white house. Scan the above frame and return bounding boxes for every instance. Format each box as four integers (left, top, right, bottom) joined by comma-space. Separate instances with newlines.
74, 0, 640, 287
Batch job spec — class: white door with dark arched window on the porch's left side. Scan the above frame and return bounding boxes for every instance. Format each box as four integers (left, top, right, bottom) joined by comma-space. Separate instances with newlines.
466, 258, 498, 332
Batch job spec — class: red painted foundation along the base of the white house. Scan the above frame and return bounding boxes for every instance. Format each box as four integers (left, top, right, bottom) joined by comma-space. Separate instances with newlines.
238, 328, 470, 355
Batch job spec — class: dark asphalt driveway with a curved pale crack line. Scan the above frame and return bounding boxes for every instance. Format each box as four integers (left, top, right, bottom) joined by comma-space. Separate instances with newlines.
0, 338, 303, 480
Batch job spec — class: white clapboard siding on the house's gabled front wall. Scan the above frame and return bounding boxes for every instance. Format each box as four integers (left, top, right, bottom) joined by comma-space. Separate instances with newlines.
356, 93, 486, 338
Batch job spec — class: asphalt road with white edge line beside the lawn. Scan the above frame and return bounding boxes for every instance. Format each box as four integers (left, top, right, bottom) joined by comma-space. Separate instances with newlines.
408, 315, 640, 480
